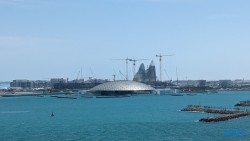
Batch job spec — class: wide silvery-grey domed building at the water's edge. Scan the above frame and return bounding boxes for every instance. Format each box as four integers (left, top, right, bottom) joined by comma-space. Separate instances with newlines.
90, 80, 154, 95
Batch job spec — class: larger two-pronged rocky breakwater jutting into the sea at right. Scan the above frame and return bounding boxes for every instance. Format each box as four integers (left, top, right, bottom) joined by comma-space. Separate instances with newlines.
181, 105, 250, 122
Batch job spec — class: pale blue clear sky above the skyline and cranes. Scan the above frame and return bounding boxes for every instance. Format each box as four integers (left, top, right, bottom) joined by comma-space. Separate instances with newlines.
0, 0, 250, 81
